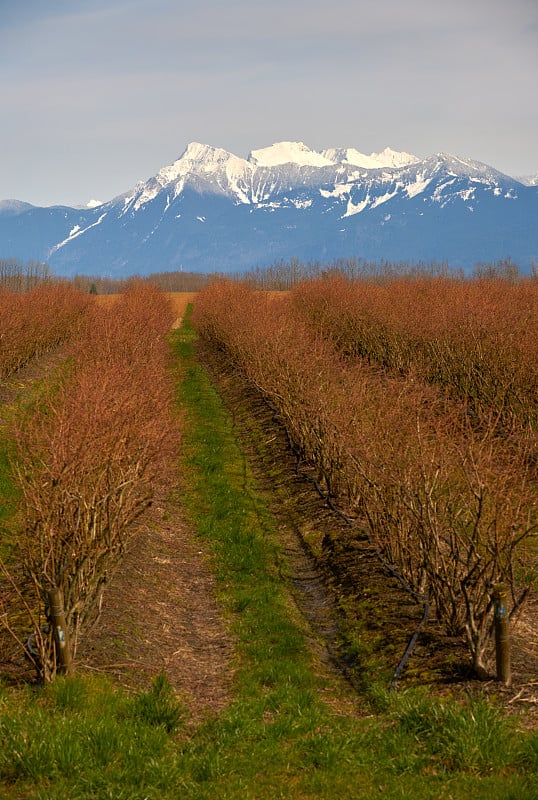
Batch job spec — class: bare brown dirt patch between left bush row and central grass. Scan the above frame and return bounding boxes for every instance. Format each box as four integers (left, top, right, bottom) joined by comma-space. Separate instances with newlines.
77, 497, 233, 718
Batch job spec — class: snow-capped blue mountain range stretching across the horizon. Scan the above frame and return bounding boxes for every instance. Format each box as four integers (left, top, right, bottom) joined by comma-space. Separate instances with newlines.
0, 142, 538, 277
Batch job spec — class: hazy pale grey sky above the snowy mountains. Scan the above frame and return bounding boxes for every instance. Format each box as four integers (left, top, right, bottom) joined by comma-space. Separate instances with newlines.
0, 0, 538, 205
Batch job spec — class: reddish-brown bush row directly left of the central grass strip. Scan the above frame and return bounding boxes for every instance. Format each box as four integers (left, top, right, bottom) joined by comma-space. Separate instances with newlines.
2, 286, 177, 680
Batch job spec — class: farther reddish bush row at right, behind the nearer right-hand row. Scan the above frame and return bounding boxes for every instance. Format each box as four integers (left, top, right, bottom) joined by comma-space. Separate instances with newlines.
294, 276, 538, 430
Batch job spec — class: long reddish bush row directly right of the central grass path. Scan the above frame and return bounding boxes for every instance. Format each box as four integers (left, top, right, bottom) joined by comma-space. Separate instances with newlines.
193, 281, 538, 674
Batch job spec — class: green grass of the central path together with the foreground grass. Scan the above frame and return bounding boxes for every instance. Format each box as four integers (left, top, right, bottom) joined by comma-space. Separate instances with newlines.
0, 308, 538, 800
